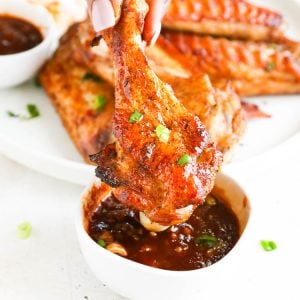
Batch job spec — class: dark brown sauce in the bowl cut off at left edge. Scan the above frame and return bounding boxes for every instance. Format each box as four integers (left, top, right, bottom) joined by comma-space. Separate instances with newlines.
0, 15, 43, 55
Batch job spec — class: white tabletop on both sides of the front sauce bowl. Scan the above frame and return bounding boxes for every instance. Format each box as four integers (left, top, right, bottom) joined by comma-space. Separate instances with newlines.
0, 136, 300, 300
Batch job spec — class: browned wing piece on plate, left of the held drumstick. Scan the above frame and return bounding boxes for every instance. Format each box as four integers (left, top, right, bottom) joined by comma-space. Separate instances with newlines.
40, 25, 114, 161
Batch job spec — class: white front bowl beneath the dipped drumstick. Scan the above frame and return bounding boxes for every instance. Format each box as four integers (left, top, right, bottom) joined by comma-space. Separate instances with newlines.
76, 174, 250, 300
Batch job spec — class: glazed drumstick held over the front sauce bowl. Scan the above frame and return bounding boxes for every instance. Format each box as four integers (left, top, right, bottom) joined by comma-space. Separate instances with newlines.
93, 0, 222, 225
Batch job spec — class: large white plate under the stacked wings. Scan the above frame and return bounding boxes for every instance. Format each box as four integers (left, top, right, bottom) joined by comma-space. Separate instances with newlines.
0, 0, 300, 185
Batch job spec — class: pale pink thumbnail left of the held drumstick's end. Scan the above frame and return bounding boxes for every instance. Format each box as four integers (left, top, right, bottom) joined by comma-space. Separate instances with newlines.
92, 0, 115, 32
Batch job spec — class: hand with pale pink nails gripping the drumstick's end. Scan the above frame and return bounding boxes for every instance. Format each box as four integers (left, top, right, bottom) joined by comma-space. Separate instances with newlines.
88, 0, 169, 45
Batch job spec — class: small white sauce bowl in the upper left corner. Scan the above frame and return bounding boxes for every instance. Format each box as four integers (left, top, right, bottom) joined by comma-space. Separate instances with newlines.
0, 0, 56, 88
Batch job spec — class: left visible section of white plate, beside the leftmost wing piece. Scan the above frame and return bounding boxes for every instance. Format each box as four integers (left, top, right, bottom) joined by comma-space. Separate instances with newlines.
0, 82, 94, 184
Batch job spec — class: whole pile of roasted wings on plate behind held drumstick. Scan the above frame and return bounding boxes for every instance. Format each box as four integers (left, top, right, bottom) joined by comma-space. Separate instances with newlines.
40, 0, 300, 160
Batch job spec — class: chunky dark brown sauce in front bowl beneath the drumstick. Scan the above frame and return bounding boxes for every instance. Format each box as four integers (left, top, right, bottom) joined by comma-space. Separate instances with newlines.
88, 196, 239, 271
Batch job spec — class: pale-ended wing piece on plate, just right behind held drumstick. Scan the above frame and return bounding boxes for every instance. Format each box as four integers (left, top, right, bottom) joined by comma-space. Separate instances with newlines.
162, 73, 246, 153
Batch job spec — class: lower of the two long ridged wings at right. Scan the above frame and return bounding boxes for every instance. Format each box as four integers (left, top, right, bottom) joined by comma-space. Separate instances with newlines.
163, 31, 300, 96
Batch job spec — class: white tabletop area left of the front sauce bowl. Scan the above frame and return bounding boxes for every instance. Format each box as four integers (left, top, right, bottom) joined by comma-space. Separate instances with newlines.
0, 155, 121, 300
